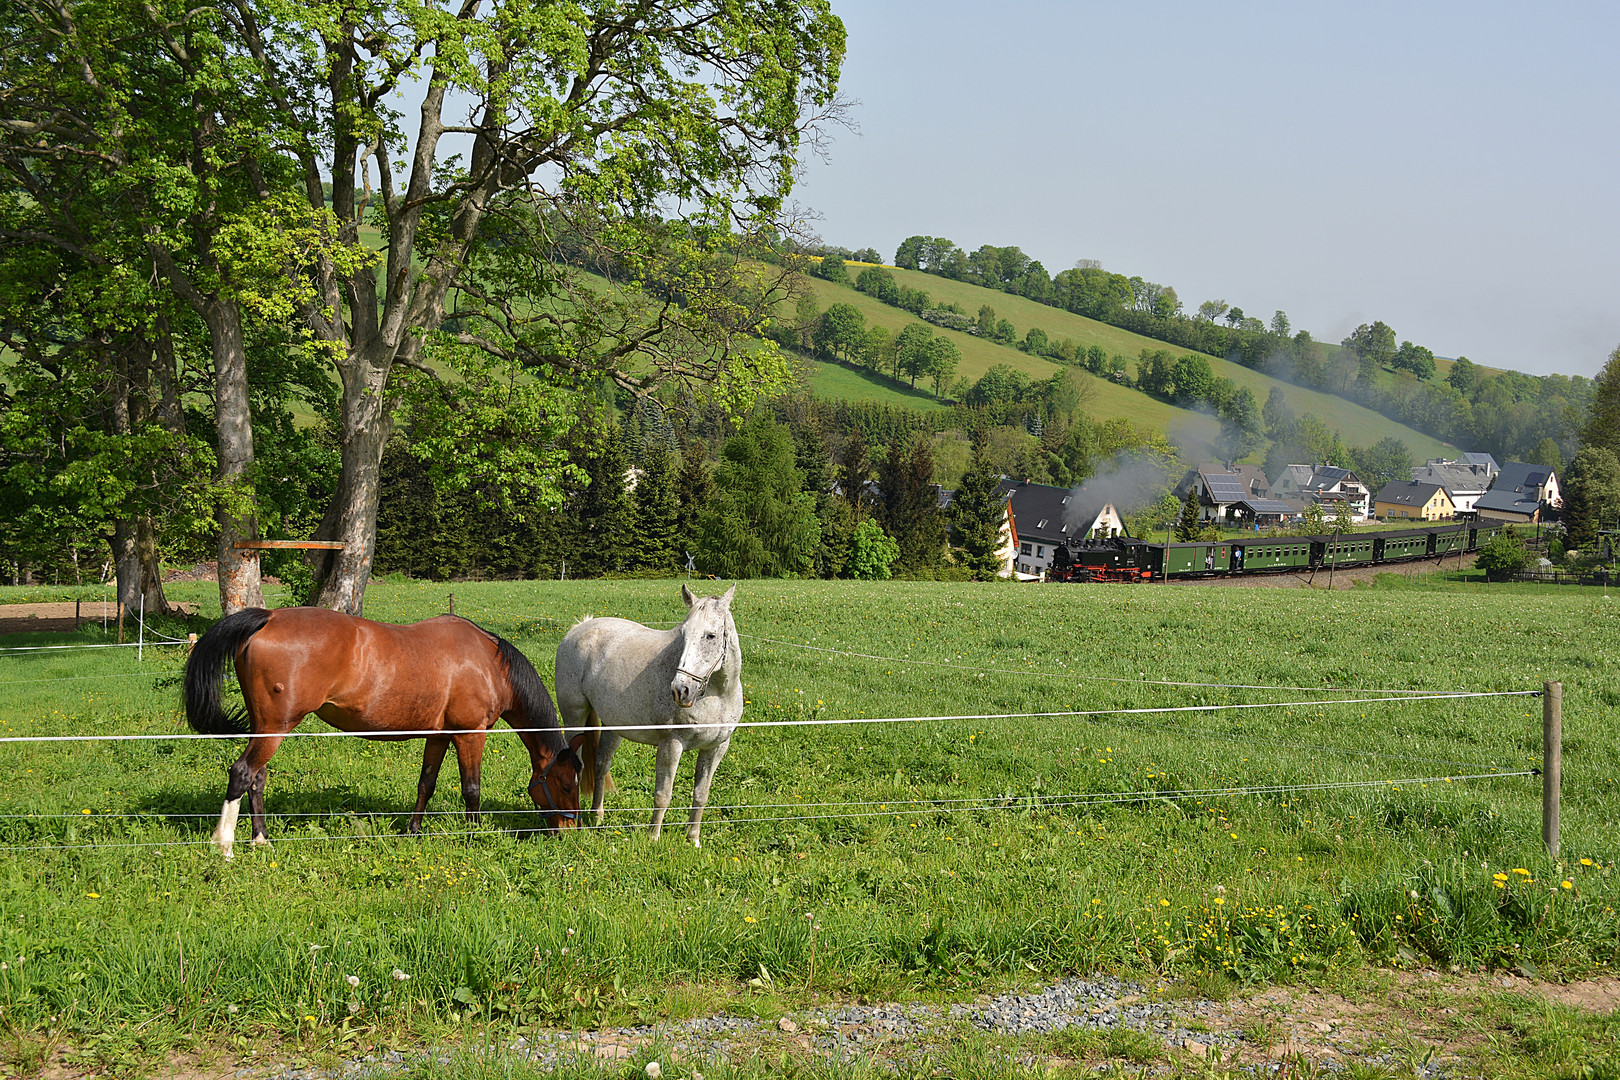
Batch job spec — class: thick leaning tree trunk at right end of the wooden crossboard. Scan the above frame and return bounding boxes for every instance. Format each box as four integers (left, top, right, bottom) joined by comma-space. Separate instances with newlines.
309, 359, 394, 615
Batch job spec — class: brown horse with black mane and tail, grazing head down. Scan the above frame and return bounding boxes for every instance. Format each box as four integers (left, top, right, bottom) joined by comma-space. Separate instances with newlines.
185, 607, 583, 858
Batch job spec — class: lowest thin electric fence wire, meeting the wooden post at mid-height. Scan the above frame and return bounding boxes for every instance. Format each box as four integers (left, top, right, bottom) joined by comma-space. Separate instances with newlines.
0, 769, 1534, 852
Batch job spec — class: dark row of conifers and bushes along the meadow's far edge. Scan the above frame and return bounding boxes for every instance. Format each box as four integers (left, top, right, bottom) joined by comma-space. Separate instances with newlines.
377, 402, 1001, 578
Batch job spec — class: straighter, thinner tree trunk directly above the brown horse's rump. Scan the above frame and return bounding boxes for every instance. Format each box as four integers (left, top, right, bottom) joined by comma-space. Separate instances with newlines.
204, 298, 264, 615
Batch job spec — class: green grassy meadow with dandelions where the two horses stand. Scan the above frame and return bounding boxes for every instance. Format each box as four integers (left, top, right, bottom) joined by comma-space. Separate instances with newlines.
0, 580, 1620, 1062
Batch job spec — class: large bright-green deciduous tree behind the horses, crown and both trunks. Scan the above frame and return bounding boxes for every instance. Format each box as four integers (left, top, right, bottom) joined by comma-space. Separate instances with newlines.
0, 0, 844, 612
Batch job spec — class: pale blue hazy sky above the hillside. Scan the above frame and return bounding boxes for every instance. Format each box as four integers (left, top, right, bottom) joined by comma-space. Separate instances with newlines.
795, 0, 1620, 376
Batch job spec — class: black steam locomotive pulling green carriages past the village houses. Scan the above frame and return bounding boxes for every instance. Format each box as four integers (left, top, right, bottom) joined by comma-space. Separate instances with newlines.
1047, 521, 1507, 581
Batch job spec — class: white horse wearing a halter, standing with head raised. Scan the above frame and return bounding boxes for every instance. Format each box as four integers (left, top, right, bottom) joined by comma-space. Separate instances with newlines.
552, 585, 742, 847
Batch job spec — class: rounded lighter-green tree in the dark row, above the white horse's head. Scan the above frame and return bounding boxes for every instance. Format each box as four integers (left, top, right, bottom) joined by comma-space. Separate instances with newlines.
693, 413, 821, 578
